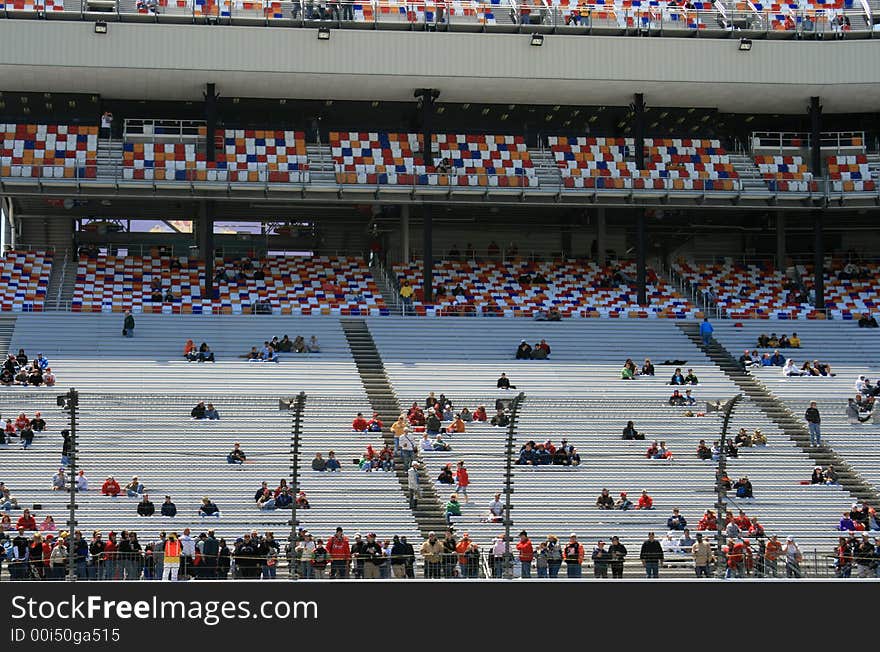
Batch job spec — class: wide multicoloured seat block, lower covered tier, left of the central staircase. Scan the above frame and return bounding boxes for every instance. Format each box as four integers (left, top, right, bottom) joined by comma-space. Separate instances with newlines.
72, 253, 388, 315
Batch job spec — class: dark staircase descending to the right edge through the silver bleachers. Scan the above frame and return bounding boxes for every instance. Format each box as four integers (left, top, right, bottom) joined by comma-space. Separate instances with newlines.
676, 322, 880, 505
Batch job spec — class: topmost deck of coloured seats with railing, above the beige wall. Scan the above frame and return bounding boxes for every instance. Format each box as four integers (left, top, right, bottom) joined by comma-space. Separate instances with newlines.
0, 0, 880, 40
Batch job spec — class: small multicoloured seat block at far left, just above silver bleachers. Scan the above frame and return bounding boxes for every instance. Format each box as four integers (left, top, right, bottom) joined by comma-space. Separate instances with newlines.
0, 251, 52, 312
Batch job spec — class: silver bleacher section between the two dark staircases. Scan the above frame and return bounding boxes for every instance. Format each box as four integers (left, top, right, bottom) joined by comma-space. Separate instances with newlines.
369, 318, 849, 566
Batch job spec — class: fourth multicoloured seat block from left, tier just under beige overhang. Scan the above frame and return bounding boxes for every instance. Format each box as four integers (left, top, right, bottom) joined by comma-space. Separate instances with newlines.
548, 136, 737, 190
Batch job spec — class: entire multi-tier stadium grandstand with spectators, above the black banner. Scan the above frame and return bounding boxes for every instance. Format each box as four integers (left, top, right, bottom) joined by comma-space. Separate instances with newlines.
0, 0, 880, 581
